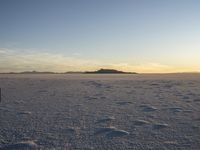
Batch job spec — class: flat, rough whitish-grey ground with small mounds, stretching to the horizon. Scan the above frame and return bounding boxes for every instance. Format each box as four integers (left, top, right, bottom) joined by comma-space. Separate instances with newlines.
0, 74, 200, 150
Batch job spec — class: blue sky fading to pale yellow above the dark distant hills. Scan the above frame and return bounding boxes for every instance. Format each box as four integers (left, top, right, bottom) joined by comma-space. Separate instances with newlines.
0, 0, 200, 73
